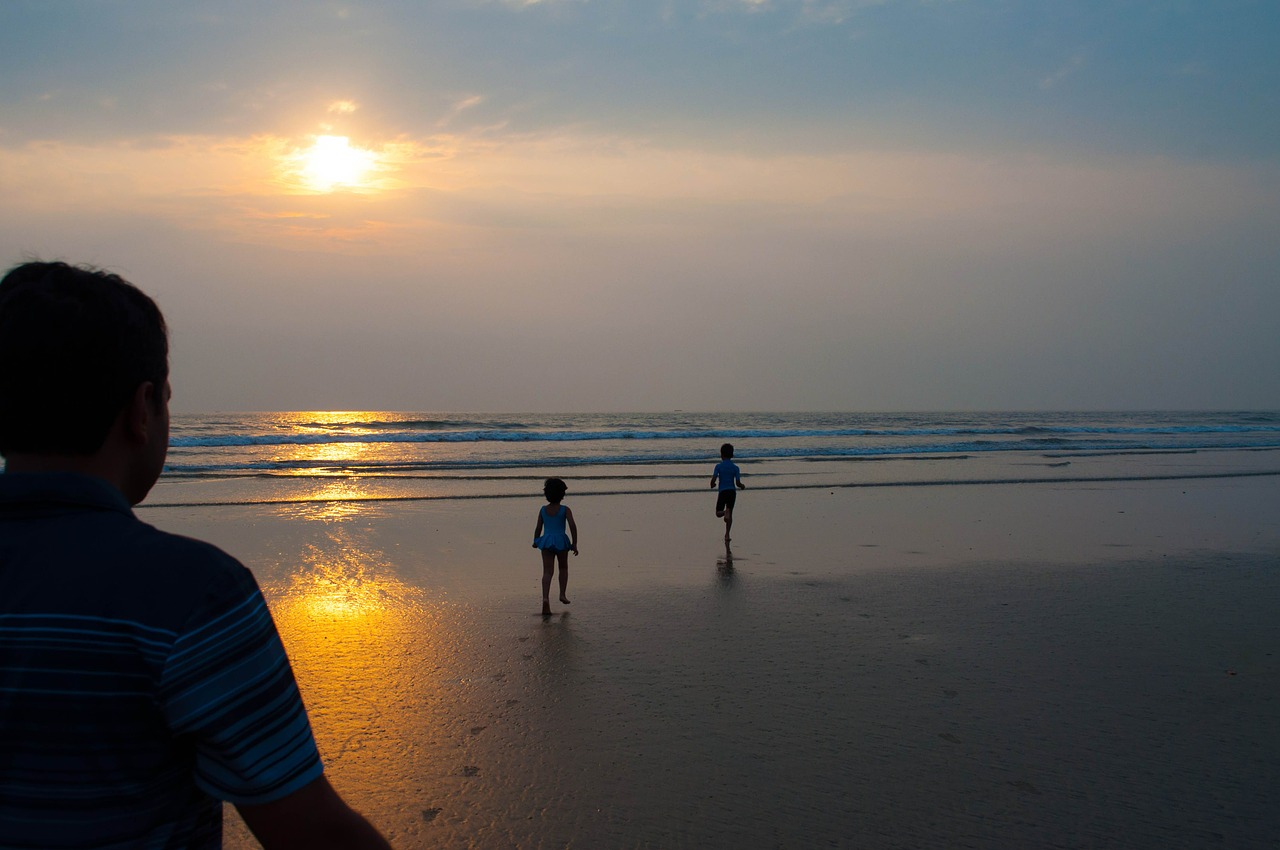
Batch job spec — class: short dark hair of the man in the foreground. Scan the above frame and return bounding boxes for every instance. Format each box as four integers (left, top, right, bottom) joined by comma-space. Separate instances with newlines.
0, 262, 169, 456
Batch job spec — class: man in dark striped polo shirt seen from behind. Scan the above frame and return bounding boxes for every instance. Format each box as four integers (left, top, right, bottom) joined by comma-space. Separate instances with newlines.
0, 262, 388, 850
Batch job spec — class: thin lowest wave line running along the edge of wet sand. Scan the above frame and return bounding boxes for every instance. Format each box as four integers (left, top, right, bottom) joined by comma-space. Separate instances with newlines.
137, 470, 1280, 509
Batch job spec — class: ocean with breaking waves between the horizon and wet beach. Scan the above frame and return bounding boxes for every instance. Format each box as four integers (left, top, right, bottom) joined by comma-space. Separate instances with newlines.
148, 411, 1280, 506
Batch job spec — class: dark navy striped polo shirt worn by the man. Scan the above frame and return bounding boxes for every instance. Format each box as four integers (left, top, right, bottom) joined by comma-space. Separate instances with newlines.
0, 474, 323, 847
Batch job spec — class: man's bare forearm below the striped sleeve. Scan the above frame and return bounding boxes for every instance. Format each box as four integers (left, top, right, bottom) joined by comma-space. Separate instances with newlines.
236, 776, 390, 850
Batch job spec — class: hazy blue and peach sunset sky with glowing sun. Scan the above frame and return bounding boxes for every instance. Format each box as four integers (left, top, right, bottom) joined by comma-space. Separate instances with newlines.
0, 0, 1280, 412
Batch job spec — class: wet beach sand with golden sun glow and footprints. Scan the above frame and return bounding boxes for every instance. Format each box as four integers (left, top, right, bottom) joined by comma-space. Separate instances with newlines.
140, 477, 1280, 849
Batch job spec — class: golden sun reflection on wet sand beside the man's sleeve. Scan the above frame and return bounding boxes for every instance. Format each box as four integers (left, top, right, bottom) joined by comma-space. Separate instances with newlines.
264, 524, 458, 808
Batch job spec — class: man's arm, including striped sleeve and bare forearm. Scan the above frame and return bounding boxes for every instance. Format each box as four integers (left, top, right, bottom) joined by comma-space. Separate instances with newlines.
156, 560, 389, 850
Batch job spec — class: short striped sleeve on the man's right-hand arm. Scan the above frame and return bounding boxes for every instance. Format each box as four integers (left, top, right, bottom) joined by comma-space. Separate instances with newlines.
160, 562, 324, 804
